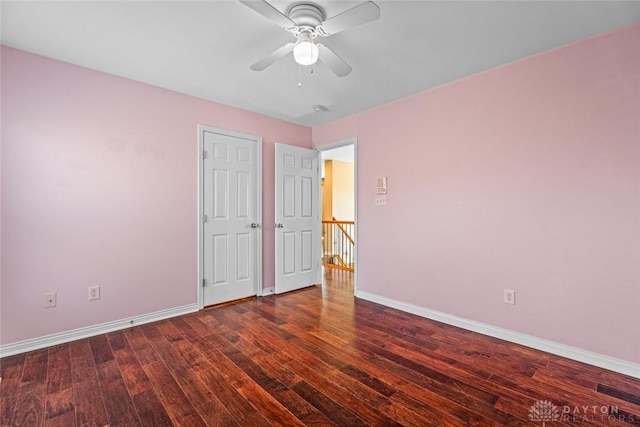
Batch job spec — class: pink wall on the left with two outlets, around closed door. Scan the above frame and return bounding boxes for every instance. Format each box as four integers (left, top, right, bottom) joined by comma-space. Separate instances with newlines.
0, 47, 311, 344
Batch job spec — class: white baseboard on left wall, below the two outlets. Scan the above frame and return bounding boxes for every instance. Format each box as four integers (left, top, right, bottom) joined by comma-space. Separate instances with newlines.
0, 303, 199, 357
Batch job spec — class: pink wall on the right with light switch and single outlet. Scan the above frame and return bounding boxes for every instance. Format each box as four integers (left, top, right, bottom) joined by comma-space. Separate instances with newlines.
313, 24, 640, 363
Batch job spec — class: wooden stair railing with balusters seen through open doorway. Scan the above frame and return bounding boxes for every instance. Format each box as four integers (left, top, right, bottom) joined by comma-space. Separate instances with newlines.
322, 217, 356, 271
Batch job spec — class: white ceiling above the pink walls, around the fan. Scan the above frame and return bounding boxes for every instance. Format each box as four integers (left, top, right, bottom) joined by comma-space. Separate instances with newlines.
1, 0, 640, 126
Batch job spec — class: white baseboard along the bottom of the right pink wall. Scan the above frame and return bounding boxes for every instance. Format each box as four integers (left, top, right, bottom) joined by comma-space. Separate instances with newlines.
356, 291, 640, 378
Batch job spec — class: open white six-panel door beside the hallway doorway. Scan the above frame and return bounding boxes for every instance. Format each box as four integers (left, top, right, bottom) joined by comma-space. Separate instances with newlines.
275, 144, 321, 294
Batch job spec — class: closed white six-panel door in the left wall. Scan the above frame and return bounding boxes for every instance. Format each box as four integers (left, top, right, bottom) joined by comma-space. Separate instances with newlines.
200, 127, 262, 305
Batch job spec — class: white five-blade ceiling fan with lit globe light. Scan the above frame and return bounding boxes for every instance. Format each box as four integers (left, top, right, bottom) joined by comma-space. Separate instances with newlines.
240, 0, 380, 77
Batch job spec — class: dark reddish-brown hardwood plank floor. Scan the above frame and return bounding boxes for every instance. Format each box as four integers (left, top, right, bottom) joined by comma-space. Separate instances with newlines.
0, 271, 640, 427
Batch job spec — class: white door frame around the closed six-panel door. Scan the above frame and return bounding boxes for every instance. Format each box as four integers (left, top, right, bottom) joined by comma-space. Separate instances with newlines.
196, 124, 263, 310
